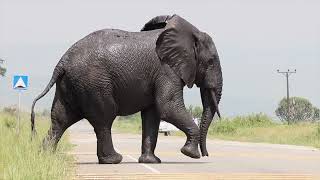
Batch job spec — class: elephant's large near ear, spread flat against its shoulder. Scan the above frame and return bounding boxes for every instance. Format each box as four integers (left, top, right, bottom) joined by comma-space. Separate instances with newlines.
156, 15, 199, 88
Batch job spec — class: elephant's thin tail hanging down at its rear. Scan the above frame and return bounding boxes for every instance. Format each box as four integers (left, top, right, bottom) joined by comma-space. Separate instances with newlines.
31, 61, 64, 136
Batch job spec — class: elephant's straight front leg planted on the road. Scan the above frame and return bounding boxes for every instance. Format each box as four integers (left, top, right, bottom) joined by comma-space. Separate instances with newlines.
139, 107, 161, 163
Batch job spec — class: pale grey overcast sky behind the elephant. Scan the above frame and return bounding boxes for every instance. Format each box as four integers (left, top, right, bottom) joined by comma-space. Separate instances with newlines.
0, 0, 320, 116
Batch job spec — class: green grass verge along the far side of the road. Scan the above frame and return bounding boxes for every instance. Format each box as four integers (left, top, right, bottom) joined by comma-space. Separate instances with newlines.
114, 113, 320, 148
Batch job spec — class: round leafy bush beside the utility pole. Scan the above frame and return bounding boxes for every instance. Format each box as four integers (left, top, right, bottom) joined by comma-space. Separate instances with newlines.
276, 97, 319, 124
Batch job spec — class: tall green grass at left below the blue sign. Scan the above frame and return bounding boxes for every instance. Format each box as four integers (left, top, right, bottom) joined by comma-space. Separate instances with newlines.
0, 112, 74, 180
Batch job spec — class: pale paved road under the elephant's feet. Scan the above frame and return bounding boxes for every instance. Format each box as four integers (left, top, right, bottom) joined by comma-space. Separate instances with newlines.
69, 121, 320, 179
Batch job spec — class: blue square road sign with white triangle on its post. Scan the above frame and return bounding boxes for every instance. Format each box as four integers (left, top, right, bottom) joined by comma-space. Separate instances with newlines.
13, 75, 29, 134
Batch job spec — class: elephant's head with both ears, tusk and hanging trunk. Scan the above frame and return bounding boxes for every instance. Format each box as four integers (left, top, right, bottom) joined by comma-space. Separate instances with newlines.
142, 15, 223, 156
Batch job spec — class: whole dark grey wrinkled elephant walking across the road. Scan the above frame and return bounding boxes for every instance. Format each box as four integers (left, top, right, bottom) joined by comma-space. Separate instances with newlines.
31, 15, 222, 163
